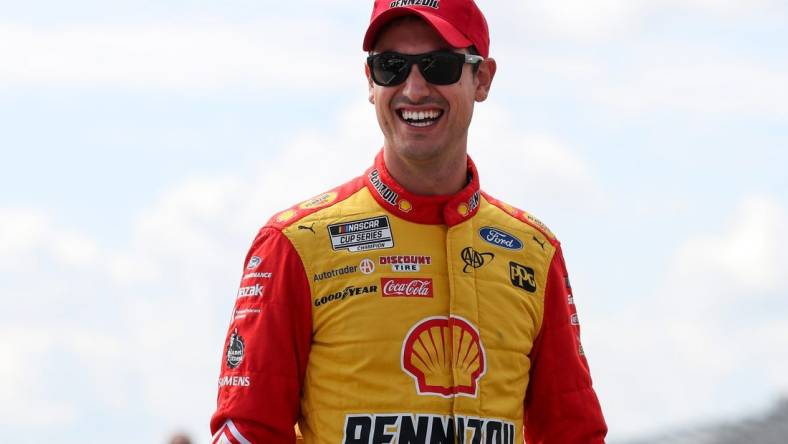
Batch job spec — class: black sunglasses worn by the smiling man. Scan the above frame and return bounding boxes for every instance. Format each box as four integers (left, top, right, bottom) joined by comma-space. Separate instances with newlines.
367, 50, 484, 86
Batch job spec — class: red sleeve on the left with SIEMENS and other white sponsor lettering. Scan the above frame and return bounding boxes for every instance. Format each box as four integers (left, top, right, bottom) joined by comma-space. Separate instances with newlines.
211, 228, 312, 444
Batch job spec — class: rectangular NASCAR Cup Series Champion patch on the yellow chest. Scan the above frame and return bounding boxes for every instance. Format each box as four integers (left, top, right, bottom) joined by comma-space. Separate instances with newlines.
328, 216, 394, 253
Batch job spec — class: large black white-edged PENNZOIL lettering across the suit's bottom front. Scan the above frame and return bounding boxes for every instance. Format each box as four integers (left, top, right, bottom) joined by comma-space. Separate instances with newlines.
342, 414, 516, 444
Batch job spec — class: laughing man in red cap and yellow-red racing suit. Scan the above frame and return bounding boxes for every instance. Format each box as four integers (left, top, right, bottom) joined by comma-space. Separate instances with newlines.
211, 0, 606, 444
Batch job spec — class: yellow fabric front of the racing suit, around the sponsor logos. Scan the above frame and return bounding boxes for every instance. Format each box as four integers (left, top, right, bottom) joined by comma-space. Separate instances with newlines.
283, 188, 555, 443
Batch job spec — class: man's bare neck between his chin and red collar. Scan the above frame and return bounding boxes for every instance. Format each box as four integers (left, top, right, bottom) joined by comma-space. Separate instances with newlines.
383, 147, 468, 196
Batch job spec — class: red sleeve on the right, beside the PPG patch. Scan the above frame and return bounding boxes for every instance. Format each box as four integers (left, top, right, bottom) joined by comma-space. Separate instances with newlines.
524, 244, 607, 444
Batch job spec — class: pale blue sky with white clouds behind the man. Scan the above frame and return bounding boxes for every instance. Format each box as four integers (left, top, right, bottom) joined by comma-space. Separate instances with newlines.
0, 0, 788, 444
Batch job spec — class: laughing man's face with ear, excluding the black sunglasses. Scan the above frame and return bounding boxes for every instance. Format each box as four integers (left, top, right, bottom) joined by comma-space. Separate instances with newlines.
367, 18, 495, 166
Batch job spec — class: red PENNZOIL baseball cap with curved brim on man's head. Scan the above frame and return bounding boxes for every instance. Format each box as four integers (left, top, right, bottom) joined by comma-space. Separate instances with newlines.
364, 0, 490, 57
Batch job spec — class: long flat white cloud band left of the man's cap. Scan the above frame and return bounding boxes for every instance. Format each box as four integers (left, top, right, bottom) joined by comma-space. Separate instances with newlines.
0, 22, 362, 93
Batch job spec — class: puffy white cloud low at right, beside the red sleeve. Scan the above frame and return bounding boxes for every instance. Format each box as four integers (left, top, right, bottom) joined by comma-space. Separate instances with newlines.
584, 196, 788, 439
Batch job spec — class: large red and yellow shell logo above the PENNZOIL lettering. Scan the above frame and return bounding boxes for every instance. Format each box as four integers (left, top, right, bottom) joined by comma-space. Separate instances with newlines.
402, 316, 487, 398
